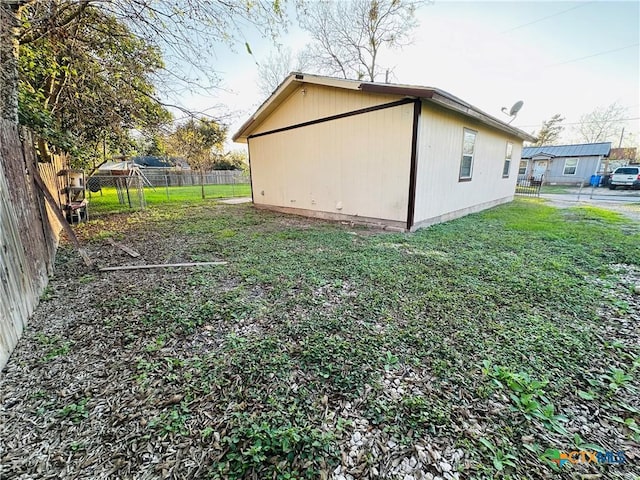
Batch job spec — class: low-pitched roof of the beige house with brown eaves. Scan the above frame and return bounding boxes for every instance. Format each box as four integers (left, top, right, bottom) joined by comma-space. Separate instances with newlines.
232, 72, 536, 142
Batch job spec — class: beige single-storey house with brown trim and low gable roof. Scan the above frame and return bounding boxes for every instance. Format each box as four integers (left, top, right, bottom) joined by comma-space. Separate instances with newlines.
233, 73, 535, 230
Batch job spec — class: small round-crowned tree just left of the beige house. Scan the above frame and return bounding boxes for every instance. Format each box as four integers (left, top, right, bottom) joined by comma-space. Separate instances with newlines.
167, 118, 227, 199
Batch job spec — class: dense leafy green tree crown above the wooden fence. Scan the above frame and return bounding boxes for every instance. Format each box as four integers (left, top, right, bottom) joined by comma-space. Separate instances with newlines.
18, 6, 170, 163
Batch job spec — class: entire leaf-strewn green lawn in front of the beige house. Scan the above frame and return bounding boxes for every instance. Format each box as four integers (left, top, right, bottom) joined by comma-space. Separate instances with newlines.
0, 200, 640, 479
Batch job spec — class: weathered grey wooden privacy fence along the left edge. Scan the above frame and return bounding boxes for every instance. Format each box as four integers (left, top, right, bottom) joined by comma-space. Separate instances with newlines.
0, 120, 65, 370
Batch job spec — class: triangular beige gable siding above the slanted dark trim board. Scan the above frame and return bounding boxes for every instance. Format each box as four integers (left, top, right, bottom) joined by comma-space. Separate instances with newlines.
252, 83, 399, 135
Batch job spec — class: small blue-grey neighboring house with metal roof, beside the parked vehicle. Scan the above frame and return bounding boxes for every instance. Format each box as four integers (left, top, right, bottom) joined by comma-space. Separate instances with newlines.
518, 142, 611, 185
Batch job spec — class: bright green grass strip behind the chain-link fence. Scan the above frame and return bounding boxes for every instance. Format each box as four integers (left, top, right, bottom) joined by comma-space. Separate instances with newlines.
89, 184, 251, 215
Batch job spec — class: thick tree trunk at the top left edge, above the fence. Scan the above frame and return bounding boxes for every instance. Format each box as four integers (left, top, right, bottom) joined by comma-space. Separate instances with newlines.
0, 1, 23, 125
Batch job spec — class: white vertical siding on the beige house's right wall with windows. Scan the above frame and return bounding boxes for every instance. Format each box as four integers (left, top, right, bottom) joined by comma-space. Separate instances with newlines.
414, 102, 522, 227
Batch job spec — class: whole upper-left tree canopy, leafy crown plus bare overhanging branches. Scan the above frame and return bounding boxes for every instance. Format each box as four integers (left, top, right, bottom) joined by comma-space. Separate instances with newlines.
0, 0, 283, 165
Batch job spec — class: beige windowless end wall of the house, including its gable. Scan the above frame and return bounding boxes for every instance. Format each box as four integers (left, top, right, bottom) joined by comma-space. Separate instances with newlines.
249, 103, 413, 222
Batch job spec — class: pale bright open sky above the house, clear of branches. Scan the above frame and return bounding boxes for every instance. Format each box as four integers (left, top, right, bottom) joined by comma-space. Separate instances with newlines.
171, 1, 640, 148
